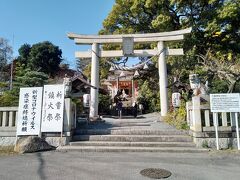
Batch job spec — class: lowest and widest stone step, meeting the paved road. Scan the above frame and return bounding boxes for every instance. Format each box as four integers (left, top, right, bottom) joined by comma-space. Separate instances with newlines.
57, 146, 208, 153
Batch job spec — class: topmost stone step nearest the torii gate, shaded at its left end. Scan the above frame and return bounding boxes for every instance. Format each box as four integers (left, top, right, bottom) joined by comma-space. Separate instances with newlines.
74, 129, 187, 135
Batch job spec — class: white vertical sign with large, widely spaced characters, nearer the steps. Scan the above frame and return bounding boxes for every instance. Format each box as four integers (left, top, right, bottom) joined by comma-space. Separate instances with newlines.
41, 85, 64, 132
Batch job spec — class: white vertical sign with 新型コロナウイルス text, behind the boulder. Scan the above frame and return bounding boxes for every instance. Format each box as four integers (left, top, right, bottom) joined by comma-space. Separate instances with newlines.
17, 87, 43, 136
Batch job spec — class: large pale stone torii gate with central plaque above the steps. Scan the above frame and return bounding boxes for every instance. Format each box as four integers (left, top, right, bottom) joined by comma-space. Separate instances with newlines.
67, 28, 191, 119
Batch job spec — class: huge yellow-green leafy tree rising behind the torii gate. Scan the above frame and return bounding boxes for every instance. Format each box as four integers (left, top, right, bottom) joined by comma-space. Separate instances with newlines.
99, 0, 240, 112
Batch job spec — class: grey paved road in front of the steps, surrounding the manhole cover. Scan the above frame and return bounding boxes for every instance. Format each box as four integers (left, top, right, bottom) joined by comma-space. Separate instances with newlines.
0, 151, 240, 180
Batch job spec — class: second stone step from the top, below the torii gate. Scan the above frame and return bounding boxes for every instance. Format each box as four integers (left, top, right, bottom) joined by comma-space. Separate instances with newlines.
73, 135, 192, 142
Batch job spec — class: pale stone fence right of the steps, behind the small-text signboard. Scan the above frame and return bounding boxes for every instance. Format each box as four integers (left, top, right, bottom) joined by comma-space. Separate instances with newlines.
186, 96, 237, 149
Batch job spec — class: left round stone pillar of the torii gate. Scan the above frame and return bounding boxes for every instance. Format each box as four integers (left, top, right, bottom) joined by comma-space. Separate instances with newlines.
89, 43, 99, 118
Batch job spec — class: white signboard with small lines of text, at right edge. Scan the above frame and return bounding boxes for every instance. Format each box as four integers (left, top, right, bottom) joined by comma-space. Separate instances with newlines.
210, 93, 240, 112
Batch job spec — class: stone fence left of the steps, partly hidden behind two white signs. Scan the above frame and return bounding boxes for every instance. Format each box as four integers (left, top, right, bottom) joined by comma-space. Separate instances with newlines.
0, 98, 76, 146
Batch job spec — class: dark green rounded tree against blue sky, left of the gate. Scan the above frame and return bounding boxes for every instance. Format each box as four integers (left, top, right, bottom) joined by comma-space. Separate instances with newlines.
18, 41, 62, 76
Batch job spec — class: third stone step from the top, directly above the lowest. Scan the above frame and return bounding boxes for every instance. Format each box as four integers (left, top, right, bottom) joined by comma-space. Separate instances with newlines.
70, 141, 195, 147
